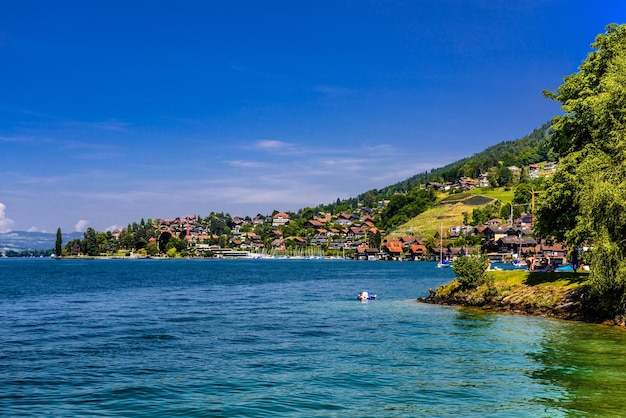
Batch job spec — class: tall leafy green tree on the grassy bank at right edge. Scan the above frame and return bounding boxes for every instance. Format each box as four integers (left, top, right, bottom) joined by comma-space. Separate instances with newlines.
536, 25, 626, 313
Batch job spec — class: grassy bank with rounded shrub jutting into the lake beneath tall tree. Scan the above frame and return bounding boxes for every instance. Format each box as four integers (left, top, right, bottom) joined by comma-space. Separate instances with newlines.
417, 270, 626, 326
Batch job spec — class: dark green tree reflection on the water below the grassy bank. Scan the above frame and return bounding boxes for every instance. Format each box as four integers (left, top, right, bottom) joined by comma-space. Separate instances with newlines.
530, 323, 626, 417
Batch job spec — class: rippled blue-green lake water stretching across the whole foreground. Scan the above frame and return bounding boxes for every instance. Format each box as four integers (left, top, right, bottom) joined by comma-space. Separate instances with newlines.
0, 259, 626, 417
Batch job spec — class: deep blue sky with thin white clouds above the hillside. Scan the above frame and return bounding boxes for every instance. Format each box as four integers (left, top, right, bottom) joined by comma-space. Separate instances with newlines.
0, 0, 626, 232
